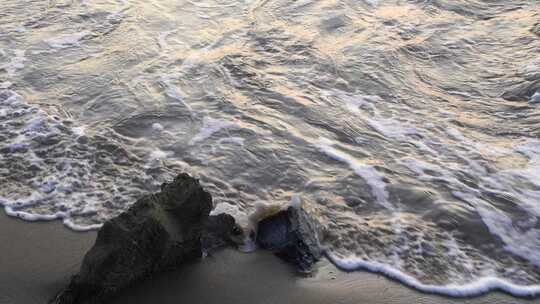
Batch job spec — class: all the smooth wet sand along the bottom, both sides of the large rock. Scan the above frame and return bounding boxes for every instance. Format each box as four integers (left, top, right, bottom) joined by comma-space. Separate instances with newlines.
0, 213, 540, 304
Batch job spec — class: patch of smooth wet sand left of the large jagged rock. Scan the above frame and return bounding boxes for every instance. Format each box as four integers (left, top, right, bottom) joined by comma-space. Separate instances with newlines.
0, 210, 96, 304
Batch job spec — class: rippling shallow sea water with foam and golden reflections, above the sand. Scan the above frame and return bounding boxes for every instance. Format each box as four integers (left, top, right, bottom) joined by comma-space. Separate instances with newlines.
0, 0, 540, 295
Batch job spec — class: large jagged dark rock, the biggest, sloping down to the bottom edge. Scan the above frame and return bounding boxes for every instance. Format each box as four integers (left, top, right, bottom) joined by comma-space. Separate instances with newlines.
52, 174, 213, 304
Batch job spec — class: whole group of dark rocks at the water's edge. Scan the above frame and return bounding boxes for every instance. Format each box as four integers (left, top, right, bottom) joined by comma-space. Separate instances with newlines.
51, 174, 321, 304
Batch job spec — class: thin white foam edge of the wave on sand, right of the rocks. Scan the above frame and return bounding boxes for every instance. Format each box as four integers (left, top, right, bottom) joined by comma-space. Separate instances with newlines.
326, 252, 540, 297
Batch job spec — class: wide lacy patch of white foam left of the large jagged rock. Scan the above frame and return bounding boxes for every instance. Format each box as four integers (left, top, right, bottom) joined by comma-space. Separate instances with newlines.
0, 90, 166, 230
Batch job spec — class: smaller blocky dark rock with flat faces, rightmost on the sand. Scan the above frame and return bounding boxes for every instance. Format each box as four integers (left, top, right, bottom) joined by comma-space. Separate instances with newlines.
257, 207, 322, 273
